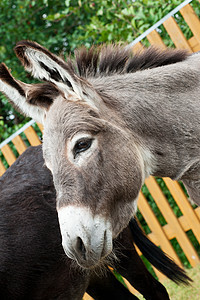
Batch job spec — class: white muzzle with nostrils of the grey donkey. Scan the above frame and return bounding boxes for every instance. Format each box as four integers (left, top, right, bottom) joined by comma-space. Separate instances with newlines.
58, 206, 112, 269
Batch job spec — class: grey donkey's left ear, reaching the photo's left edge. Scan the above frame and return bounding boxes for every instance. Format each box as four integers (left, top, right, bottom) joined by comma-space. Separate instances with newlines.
0, 63, 52, 123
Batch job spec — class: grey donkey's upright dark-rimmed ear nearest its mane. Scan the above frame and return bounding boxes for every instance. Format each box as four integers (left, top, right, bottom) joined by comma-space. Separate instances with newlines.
14, 40, 82, 98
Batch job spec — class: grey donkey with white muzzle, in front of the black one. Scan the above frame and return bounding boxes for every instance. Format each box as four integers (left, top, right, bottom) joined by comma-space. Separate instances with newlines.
0, 41, 200, 268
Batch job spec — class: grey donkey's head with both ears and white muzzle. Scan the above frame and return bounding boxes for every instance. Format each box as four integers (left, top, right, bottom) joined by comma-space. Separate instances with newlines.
0, 41, 144, 268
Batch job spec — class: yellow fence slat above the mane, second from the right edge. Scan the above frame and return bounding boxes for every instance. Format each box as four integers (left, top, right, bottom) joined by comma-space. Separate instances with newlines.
163, 17, 192, 52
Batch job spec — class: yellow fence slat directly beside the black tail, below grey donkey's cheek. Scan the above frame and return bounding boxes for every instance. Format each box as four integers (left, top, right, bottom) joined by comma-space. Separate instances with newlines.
138, 193, 182, 266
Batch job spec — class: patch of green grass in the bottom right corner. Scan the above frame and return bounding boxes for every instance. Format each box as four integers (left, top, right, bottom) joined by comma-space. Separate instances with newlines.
137, 264, 200, 300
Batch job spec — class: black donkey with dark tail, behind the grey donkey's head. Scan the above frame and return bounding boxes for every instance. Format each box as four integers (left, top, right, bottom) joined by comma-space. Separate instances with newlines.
0, 146, 189, 300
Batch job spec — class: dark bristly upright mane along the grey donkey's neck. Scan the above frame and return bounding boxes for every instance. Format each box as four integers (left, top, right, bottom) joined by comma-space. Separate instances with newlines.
68, 45, 189, 78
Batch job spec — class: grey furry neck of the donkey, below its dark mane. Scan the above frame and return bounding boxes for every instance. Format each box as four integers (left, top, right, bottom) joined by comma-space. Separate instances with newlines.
90, 64, 200, 179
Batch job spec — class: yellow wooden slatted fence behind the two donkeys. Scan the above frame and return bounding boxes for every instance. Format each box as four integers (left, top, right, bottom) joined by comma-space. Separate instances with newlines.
0, 1, 200, 300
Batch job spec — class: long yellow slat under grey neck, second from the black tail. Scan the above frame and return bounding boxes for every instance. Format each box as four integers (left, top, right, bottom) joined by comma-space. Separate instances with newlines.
145, 176, 199, 267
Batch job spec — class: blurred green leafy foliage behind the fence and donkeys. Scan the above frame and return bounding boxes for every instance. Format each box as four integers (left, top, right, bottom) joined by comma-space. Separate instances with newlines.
0, 0, 200, 274
